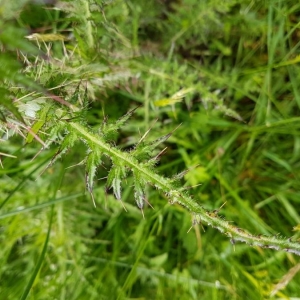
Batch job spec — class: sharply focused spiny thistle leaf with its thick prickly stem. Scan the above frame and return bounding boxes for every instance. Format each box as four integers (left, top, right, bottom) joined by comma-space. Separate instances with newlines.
17, 100, 300, 255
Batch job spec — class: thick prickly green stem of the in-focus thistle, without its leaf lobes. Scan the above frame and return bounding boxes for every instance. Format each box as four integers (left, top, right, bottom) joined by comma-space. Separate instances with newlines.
68, 122, 300, 255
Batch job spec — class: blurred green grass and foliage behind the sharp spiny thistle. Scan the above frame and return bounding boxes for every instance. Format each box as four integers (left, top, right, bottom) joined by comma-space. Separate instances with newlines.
0, 0, 300, 299
